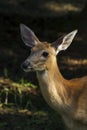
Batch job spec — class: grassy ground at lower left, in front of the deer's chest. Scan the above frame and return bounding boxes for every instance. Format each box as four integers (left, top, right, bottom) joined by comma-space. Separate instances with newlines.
0, 78, 64, 130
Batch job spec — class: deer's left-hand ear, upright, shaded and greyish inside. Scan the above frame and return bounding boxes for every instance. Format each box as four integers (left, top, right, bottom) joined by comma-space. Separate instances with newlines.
20, 24, 40, 47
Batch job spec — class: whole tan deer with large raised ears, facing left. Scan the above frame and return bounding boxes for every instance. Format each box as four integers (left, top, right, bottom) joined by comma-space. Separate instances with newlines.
20, 24, 87, 130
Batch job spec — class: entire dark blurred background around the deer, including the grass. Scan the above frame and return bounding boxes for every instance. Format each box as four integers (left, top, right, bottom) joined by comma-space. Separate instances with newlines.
0, 0, 87, 130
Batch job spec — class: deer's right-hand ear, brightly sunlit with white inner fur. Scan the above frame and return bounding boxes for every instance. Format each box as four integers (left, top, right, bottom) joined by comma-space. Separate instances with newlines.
52, 30, 77, 54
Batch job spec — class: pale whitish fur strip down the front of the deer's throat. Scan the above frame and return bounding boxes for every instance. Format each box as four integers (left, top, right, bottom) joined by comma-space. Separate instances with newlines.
38, 71, 63, 111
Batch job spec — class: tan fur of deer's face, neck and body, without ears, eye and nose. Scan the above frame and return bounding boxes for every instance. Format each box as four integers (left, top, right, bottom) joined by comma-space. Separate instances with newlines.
22, 43, 87, 130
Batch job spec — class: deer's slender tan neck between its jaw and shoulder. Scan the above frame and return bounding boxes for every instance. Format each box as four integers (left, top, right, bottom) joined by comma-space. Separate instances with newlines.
37, 62, 69, 110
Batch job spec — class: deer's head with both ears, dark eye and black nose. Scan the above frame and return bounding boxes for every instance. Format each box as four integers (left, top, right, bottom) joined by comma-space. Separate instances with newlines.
20, 24, 77, 72
